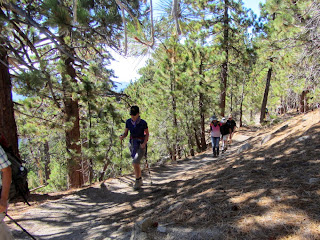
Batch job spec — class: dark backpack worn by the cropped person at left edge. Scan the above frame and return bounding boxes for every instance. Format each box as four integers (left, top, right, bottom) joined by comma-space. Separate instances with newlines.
0, 146, 30, 206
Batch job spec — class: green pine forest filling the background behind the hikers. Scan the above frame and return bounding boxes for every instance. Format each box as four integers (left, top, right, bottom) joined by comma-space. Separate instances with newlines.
0, 0, 320, 192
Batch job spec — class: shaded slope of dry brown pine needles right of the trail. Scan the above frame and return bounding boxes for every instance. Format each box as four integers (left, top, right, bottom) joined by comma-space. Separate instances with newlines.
149, 109, 320, 239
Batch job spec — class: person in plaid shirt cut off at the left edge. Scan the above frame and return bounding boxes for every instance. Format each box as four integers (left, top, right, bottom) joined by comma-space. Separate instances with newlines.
0, 145, 13, 240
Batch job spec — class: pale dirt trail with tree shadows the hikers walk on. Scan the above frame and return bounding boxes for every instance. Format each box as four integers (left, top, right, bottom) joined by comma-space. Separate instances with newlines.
7, 134, 247, 240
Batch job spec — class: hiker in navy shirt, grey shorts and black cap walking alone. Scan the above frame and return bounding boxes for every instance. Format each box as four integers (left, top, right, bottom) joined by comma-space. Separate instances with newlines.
120, 106, 149, 190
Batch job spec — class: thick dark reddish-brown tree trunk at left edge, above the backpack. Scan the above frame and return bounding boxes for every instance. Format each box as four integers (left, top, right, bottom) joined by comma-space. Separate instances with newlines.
0, 48, 19, 156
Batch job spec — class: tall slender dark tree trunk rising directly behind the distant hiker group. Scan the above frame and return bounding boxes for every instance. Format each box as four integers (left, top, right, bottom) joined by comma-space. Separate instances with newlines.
220, 0, 229, 117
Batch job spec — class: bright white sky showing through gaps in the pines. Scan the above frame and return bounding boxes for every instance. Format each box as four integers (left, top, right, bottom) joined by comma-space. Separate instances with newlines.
111, 0, 265, 88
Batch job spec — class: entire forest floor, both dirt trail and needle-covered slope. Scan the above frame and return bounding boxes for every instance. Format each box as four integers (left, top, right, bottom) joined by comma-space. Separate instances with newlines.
6, 110, 320, 240
